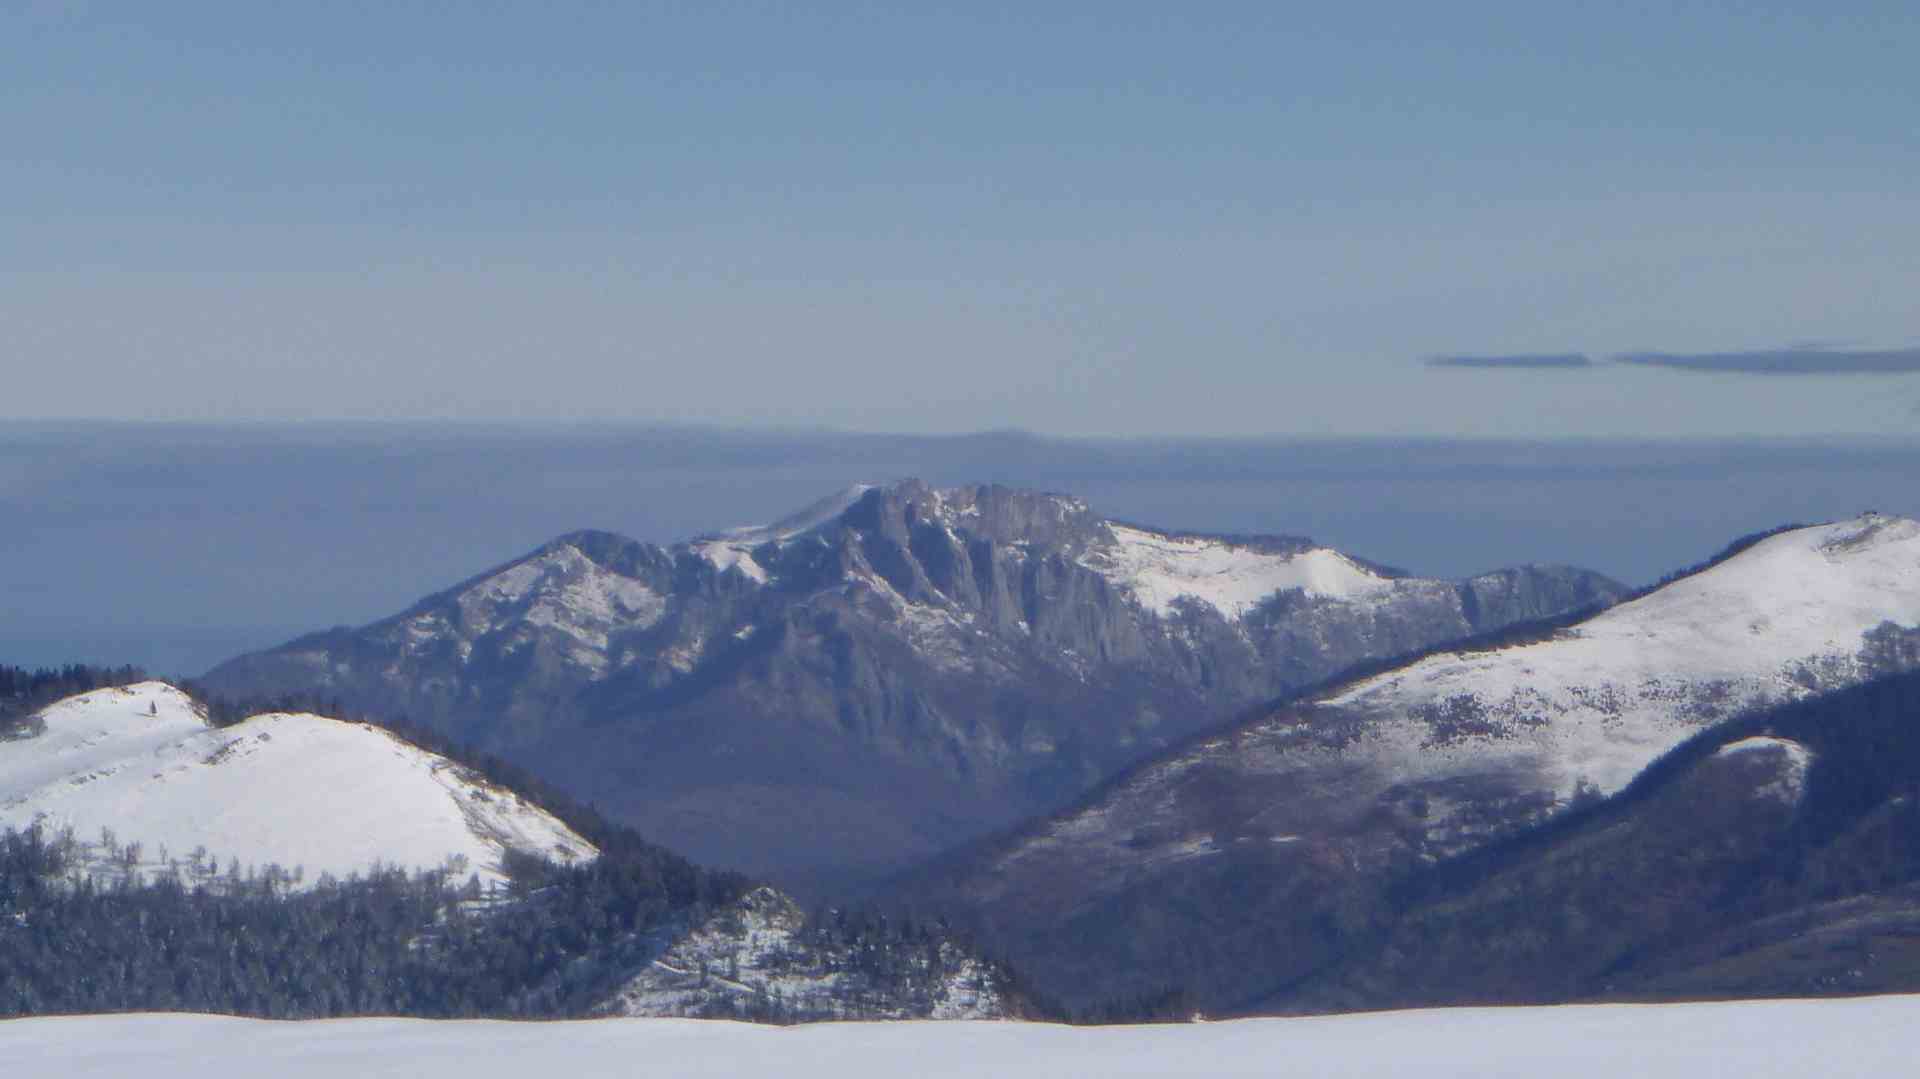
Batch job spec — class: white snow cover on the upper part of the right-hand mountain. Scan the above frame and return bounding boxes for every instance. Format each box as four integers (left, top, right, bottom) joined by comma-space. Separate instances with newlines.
1317, 515, 1920, 797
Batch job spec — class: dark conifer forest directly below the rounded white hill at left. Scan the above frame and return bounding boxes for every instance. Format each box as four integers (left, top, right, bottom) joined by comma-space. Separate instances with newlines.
0, 829, 745, 1019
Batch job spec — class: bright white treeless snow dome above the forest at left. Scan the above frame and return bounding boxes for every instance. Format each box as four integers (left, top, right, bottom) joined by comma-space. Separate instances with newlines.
0, 682, 593, 883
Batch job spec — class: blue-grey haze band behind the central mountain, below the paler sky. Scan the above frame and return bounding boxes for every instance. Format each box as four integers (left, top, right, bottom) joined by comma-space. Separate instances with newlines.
0, 424, 1920, 676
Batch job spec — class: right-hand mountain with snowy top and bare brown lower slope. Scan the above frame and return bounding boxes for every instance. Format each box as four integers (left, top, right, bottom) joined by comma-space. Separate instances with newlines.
900, 515, 1920, 995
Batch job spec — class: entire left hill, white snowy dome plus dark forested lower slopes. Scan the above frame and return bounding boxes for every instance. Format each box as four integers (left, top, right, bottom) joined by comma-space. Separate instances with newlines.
0, 682, 1012, 1021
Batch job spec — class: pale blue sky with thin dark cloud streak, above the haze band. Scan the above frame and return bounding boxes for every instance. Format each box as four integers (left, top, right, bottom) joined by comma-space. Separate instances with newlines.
0, 0, 1920, 438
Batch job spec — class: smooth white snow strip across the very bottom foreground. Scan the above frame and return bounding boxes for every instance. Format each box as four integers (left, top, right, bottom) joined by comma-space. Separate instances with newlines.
15, 996, 1920, 1079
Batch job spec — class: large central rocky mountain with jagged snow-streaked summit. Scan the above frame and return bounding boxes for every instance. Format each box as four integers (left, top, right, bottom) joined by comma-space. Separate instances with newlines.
207, 480, 1622, 883
